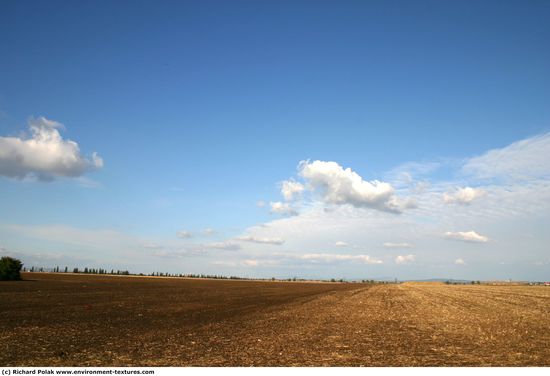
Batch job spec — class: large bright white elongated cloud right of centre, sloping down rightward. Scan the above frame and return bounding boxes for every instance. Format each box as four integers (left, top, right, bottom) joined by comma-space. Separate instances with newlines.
298, 161, 413, 213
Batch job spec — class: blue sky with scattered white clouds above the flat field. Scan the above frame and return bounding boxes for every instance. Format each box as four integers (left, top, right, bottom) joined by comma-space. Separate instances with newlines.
0, 0, 550, 280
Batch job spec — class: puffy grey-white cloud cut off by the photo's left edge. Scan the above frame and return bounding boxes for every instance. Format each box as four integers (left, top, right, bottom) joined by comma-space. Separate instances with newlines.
0, 117, 103, 181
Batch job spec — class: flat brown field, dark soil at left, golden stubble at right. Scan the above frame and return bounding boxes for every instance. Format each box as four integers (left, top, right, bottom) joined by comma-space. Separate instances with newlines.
0, 273, 550, 366
